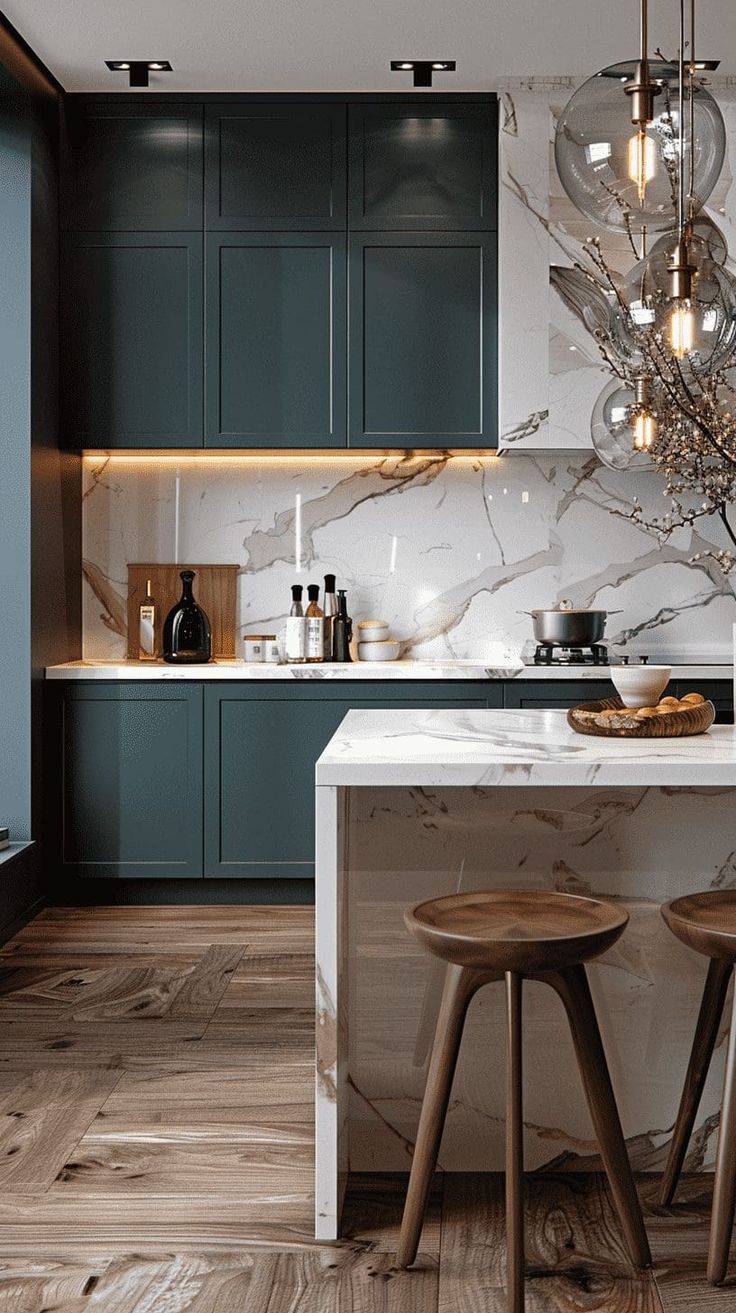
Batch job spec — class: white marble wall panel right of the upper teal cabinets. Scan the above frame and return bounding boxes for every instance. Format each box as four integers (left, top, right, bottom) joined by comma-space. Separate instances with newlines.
499, 78, 736, 450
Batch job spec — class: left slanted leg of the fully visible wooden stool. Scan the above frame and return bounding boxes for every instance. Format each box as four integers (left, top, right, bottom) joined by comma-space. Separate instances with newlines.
396, 964, 480, 1267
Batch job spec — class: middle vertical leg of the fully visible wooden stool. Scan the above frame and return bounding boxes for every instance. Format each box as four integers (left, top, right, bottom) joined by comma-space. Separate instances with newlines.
505, 972, 523, 1313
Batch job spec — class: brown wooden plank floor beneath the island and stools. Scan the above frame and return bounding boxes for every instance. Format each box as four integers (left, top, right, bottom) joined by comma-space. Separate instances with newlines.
0, 907, 736, 1313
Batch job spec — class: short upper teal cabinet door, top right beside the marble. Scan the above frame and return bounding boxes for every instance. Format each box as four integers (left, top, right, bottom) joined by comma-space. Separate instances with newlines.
349, 101, 496, 231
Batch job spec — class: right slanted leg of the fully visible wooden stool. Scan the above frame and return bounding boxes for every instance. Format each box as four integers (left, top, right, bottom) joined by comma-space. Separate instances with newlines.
547, 966, 652, 1267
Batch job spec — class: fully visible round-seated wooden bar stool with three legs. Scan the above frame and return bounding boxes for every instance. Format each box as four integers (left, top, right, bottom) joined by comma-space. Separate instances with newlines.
398, 890, 651, 1313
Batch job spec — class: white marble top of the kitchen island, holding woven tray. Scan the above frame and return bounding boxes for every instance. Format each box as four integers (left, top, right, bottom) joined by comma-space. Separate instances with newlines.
316, 710, 736, 788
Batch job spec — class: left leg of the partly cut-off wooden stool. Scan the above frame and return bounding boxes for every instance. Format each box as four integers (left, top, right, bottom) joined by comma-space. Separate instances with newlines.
660, 957, 732, 1208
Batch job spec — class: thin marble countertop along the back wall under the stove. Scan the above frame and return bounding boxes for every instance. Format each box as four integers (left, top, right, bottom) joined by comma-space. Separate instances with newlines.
46, 659, 733, 680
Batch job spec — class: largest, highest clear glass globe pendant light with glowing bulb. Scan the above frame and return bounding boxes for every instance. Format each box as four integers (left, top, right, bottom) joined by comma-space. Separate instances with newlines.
555, 0, 726, 232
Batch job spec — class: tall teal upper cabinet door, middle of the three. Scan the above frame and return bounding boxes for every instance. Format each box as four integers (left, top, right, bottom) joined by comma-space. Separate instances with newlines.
205, 232, 346, 448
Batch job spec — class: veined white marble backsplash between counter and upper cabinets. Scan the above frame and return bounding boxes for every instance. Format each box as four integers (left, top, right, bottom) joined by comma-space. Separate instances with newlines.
83, 452, 736, 660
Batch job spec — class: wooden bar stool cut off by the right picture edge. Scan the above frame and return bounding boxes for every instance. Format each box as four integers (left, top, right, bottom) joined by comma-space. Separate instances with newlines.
661, 889, 736, 1285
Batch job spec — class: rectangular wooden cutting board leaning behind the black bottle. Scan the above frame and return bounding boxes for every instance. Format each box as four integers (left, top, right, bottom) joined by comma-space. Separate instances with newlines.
127, 562, 237, 660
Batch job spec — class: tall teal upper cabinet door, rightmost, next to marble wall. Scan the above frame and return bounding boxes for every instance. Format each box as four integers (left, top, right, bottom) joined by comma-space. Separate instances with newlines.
349, 232, 496, 448
